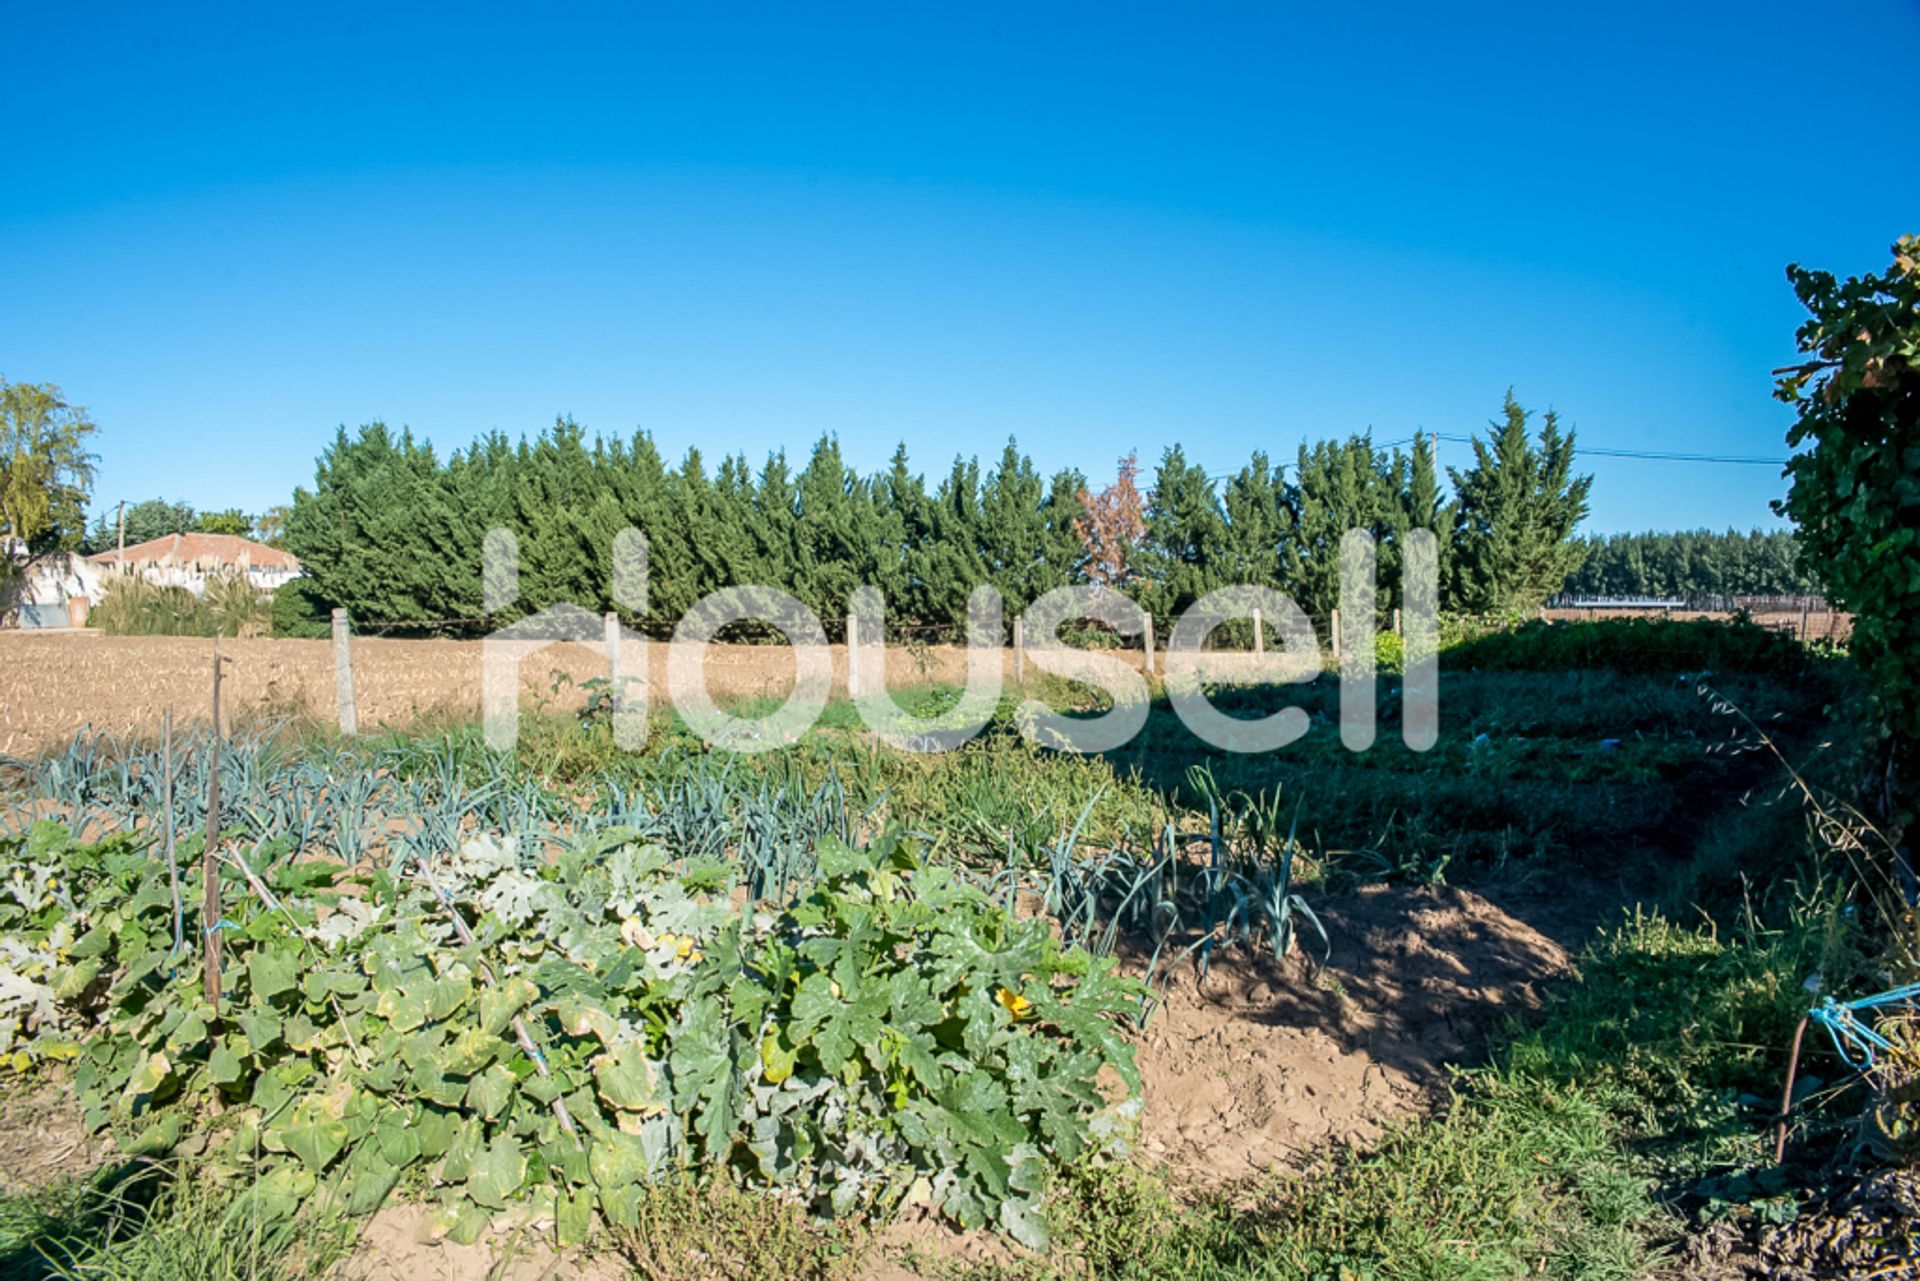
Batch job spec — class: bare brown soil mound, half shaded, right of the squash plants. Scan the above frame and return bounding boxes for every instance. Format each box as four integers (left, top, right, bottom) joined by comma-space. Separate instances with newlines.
1139, 885, 1571, 1185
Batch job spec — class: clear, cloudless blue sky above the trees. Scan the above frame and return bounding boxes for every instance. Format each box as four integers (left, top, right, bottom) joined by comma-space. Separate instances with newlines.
0, 0, 1920, 530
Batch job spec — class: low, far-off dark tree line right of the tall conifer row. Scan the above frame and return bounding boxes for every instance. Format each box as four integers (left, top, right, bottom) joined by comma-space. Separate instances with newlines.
1565, 530, 1818, 599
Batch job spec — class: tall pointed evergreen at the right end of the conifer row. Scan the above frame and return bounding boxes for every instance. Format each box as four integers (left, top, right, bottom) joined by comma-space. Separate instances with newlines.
1448, 390, 1594, 613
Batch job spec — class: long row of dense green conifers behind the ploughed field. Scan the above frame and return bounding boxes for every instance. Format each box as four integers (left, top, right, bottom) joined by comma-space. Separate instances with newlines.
280, 394, 1590, 634
